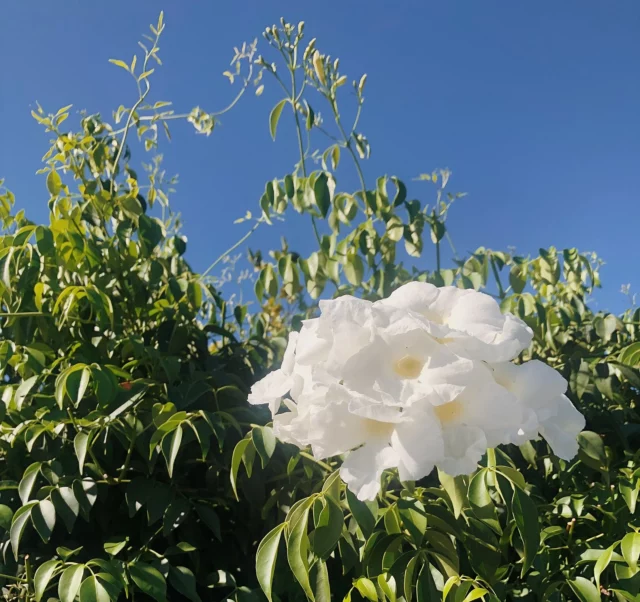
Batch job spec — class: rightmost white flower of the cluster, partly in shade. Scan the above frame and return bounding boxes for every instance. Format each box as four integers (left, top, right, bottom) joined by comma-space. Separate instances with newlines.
492, 360, 585, 460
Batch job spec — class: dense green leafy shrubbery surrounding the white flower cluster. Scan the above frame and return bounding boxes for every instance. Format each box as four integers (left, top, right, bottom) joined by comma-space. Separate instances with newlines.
0, 14, 640, 602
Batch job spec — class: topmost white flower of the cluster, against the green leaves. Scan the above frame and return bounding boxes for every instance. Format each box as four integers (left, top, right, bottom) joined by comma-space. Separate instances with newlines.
378, 282, 533, 362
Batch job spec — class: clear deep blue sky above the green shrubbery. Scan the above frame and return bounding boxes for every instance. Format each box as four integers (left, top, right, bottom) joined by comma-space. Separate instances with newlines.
0, 0, 640, 311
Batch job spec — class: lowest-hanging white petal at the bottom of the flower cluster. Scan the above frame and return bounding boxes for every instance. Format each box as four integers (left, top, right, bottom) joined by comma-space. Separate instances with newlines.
340, 440, 398, 501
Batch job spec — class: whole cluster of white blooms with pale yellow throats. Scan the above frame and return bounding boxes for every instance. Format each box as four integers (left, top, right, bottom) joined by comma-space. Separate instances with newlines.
249, 282, 584, 500
